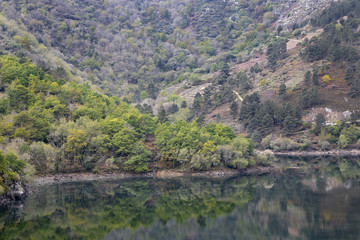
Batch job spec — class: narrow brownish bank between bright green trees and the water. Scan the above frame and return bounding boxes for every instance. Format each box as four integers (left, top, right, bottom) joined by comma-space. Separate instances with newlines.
30, 166, 277, 186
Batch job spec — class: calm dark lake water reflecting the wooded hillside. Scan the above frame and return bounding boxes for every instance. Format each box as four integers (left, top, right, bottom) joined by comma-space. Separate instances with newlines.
0, 162, 360, 240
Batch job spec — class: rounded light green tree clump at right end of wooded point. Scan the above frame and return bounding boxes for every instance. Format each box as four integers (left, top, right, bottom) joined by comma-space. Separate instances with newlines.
155, 121, 253, 170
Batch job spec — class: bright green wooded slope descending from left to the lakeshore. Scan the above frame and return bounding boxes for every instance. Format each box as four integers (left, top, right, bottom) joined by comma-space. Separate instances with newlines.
0, 56, 256, 197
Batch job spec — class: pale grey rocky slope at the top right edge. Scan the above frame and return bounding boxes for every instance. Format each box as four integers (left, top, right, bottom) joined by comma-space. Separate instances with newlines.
274, 0, 334, 30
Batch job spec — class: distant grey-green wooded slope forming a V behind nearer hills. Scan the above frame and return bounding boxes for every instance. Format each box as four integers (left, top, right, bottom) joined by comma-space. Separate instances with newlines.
0, 0, 296, 95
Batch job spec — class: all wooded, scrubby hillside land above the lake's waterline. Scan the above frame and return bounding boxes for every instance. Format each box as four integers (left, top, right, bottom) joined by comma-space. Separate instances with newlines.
0, 0, 360, 199
